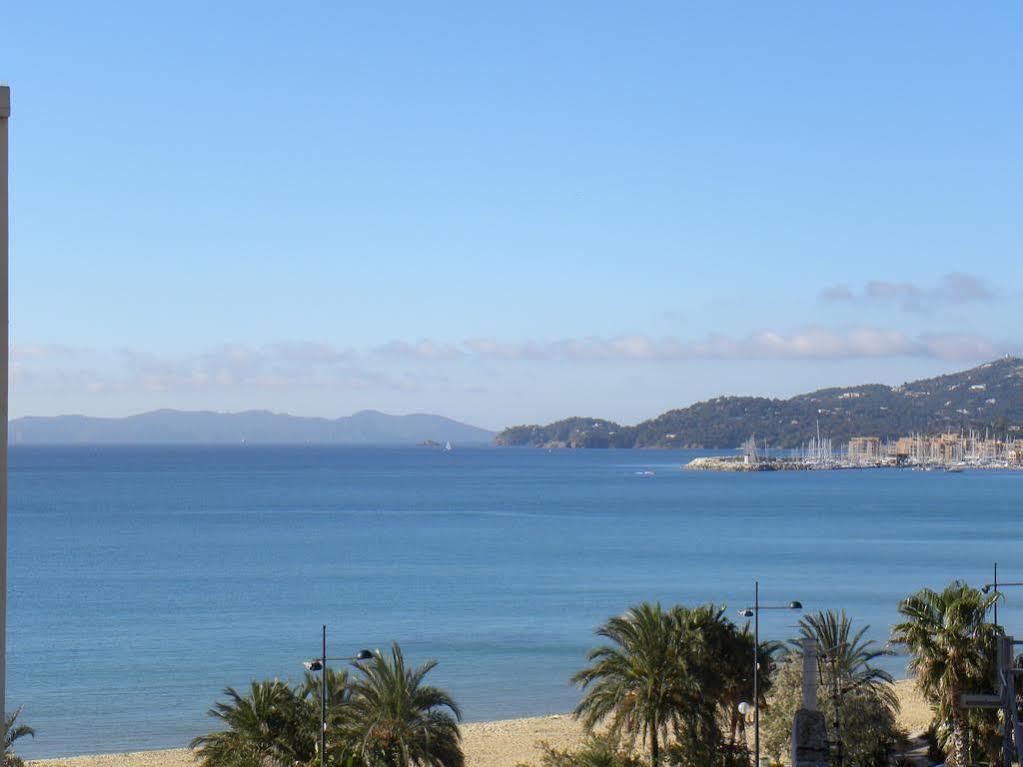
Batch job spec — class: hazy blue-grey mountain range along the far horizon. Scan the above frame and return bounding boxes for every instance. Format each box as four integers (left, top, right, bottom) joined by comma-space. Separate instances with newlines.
9, 410, 494, 445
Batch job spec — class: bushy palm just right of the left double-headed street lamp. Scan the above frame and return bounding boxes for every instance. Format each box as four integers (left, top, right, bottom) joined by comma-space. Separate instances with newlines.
344, 642, 465, 767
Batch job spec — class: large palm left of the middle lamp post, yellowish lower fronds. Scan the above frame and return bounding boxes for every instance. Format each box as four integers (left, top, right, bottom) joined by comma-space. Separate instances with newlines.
572, 602, 692, 767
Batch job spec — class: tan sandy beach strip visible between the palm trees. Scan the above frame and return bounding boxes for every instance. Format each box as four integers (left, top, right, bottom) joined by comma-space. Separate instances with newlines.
30, 679, 931, 767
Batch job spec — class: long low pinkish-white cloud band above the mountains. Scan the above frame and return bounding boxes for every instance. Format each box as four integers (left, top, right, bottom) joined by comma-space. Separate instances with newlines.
11, 327, 1017, 394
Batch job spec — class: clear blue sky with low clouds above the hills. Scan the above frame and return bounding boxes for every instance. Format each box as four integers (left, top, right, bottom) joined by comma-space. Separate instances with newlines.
0, 1, 1023, 426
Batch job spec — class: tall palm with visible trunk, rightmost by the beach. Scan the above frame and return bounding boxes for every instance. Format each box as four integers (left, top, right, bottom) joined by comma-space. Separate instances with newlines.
892, 581, 1002, 765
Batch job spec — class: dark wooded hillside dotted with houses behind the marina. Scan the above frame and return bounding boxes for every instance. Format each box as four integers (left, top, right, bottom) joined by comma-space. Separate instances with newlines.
496, 357, 1023, 448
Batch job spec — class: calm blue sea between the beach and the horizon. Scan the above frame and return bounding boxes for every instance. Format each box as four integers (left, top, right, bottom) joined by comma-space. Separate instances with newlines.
7, 447, 1023, 757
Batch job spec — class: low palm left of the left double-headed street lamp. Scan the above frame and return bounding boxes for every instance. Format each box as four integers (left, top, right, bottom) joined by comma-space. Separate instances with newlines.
190, 679, 319, 767
